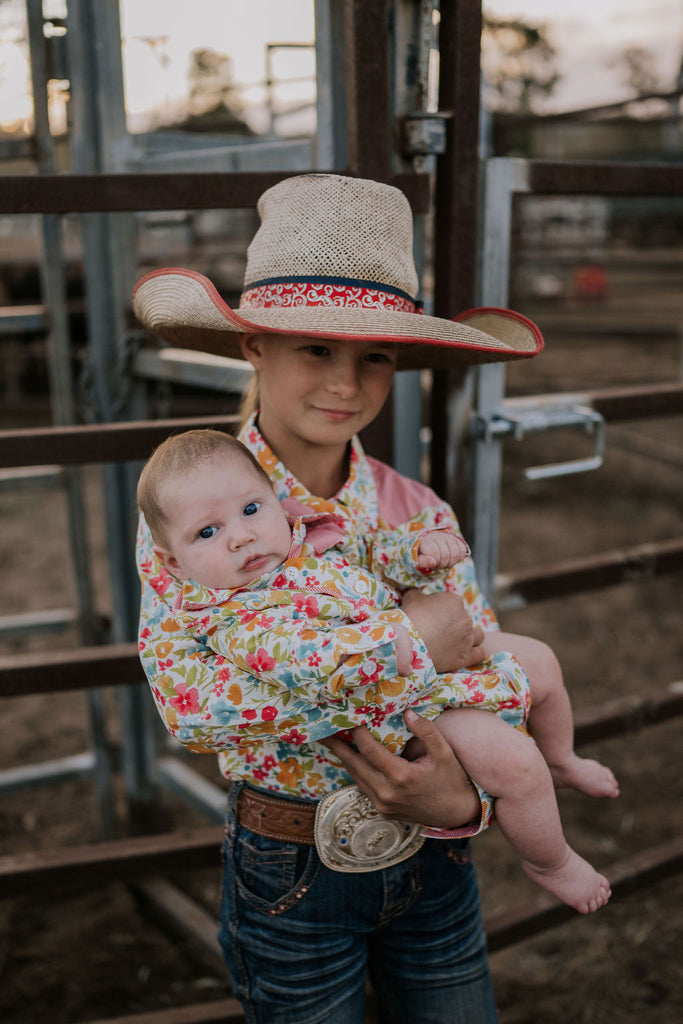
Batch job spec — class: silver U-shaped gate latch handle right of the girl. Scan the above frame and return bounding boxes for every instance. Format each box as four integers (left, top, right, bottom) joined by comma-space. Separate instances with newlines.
472, 404, 605, 480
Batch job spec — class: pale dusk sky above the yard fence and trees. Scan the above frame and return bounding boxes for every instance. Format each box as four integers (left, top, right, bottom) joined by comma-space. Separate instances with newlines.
0, 0, 683, 131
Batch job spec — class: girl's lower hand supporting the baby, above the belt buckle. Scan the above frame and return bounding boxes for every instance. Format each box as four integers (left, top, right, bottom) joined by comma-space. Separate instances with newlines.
322, 711, 481, 828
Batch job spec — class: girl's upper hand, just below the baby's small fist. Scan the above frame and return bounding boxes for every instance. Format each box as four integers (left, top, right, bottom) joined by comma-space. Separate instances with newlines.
400, 590, 485, 672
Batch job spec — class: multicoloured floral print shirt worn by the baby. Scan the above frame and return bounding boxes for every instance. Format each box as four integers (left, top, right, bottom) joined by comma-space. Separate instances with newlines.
174, 506, 417, 712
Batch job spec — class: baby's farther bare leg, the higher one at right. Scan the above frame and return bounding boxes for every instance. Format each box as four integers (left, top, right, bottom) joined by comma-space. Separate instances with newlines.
482, 633, 618, 797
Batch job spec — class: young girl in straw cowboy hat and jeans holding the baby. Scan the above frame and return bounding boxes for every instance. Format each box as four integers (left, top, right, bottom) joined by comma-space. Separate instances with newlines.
134, 175, 561, 1024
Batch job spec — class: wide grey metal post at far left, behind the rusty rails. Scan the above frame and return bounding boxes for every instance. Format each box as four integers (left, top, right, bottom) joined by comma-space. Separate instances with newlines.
67, 0, 156, 813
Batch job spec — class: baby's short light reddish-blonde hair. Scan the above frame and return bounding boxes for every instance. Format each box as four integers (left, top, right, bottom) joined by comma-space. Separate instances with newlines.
137, 429, 270, 545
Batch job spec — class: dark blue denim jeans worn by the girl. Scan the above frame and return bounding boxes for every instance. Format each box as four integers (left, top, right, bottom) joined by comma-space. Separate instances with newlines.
219, 786, 498, 1024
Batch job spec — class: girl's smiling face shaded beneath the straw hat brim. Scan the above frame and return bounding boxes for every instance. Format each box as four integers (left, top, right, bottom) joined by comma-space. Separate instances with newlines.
242, 335, 396, 461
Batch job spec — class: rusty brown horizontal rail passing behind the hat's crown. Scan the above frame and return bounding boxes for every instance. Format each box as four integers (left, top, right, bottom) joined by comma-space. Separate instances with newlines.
0, 169, 429, 214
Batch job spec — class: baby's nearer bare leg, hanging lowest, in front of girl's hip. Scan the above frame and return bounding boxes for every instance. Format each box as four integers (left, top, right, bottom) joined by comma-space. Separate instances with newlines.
407, 708, 611, 913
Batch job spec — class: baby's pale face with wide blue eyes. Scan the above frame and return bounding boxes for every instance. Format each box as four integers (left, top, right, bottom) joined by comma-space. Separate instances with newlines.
158, 454, 292, 590
